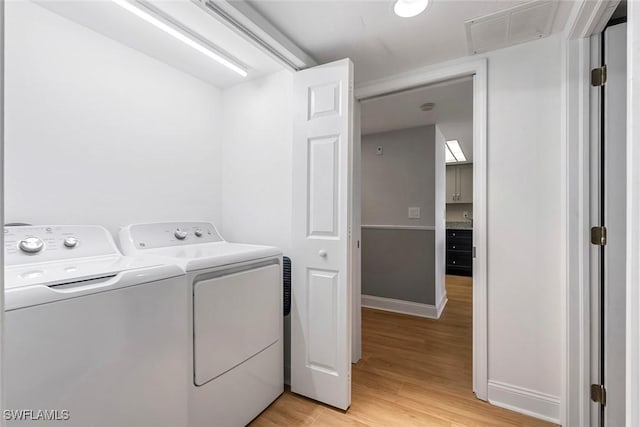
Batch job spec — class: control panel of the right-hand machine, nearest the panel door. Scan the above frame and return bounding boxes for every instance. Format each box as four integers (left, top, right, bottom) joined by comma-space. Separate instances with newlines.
125, 222, 224, 249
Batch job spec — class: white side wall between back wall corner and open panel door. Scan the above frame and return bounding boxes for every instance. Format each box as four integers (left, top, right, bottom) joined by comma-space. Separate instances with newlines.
221, 71, 293, 251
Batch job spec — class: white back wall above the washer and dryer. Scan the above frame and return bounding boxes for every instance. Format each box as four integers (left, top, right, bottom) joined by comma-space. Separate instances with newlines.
5, 2, 222, 231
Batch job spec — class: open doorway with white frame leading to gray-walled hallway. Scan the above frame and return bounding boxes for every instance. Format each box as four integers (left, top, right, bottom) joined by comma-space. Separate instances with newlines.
353, 61, 487, 418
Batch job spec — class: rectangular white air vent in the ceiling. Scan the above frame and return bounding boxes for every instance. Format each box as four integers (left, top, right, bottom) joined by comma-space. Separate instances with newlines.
465, 0, 558, 55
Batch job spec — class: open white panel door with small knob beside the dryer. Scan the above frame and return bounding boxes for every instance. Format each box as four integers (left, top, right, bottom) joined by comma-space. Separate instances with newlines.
291, 59, 354, 409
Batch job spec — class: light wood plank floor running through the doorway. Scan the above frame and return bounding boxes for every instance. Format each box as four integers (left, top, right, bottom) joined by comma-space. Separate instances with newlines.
251, 276, 553, 427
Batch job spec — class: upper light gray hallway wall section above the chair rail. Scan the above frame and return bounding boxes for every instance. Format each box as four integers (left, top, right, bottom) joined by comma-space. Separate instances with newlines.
362, 126, 435, 226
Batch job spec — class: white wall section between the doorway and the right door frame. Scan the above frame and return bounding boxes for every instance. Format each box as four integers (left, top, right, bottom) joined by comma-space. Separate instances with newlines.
487, 36, 565, 418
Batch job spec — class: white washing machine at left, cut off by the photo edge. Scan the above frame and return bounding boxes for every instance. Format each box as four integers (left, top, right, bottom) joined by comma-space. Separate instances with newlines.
3, 225, 189, 427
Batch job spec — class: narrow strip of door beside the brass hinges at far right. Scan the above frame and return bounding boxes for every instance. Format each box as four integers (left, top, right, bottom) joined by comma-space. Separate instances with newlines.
602, 24, 627, 427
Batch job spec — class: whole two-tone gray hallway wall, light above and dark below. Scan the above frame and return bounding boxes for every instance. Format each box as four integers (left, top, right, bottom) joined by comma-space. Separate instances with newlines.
362, 126, 436, 305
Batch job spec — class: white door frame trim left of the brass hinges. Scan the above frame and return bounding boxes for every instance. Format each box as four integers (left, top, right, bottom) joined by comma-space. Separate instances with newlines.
560, 0, 619, 426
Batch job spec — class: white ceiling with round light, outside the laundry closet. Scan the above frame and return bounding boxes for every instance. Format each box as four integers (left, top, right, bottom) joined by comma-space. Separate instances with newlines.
249, 0, 573, 84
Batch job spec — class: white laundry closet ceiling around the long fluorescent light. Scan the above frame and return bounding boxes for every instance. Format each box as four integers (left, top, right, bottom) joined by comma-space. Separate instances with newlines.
36, 0, 283, 88
